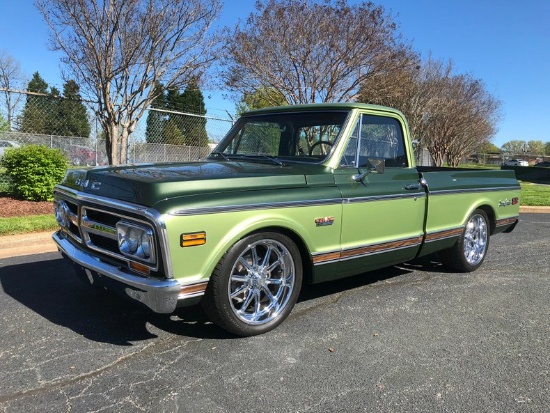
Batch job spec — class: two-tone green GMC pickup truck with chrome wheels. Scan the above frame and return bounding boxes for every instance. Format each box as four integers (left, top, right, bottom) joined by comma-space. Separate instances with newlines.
53, 103, 520, 336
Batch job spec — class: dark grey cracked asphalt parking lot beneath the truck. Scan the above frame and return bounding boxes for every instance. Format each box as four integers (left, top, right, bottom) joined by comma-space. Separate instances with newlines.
0, 214, 550, 413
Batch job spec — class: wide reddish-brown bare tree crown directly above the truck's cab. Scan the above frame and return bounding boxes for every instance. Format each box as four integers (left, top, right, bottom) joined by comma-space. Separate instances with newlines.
222, 0, 416, 104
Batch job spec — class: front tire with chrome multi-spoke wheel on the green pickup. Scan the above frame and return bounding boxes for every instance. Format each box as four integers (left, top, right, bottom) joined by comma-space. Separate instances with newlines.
201, 232, 303, 337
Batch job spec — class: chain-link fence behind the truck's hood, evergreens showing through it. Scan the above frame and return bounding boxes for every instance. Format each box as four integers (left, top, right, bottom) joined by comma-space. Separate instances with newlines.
0, 90, 232, 193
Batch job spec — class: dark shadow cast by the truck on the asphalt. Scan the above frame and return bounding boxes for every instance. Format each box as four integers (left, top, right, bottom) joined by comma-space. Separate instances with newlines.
0, 253, 448, 346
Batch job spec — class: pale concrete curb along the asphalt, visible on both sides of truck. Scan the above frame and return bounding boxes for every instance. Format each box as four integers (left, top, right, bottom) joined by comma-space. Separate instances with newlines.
0, 206, 550, 259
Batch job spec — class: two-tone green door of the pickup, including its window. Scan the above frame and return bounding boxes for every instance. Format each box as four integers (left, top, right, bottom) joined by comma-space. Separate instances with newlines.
335, 114, 426, 272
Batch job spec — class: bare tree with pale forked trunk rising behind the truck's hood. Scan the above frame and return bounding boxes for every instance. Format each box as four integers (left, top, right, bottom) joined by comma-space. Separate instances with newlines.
36, 0, 220, 165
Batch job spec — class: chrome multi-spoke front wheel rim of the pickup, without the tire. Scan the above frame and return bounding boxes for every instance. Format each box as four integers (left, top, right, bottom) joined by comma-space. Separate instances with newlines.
228, 239, 296, 325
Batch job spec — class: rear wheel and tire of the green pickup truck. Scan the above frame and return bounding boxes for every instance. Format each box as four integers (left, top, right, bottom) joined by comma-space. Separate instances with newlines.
439, 209, 490, 272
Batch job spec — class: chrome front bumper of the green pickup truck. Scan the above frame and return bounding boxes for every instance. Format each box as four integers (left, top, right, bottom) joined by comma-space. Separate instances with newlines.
53, 231, 182, 313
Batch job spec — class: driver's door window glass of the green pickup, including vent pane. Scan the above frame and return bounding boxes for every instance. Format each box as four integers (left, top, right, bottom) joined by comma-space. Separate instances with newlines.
341, 115, 408, 168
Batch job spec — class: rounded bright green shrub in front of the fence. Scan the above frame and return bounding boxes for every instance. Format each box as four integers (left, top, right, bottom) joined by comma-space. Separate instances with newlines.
0, 145, 69, 201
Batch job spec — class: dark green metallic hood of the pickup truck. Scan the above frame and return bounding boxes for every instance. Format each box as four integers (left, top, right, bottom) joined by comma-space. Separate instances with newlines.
62, 161, 334, 207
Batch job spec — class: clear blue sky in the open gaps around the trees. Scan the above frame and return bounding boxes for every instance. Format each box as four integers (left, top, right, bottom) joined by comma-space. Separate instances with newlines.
0, 0, 550, 146
